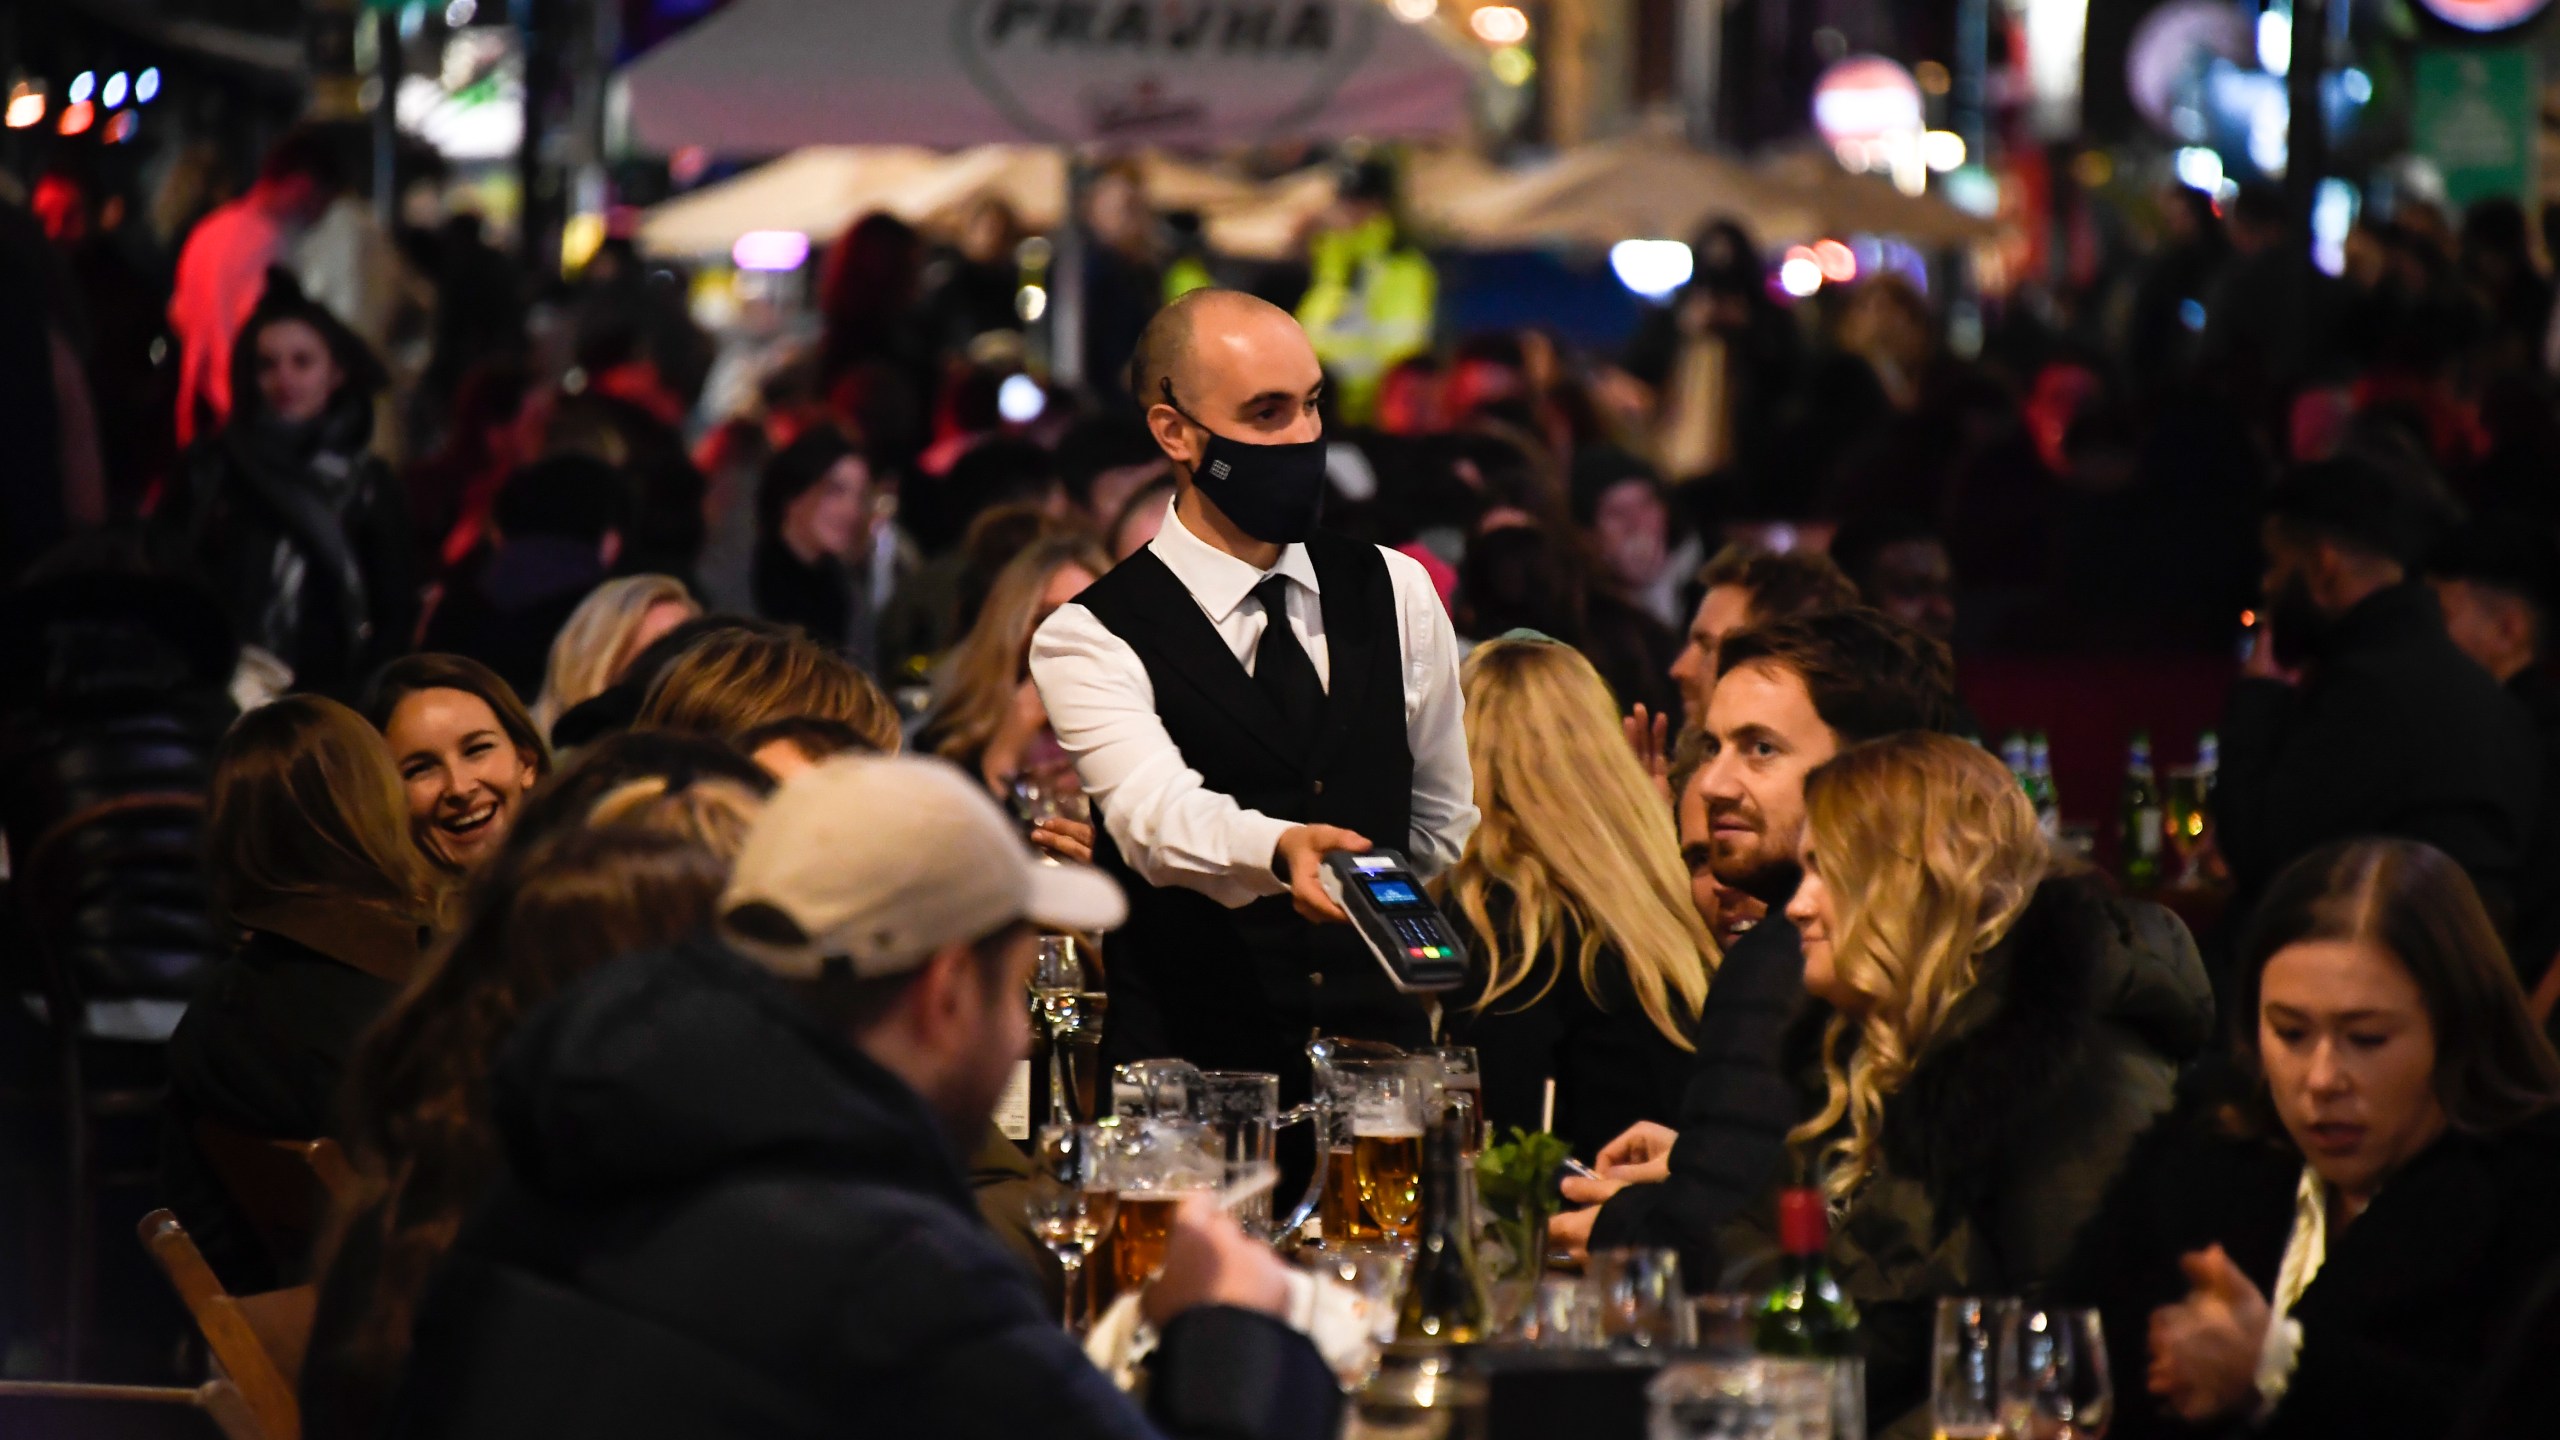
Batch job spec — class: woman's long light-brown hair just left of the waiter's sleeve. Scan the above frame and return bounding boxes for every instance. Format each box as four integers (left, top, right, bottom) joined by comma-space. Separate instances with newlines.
916, 530, 1111, 825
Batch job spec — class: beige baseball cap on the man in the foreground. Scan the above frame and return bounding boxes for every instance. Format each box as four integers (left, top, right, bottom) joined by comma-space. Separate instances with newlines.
719, 756, 1129, 979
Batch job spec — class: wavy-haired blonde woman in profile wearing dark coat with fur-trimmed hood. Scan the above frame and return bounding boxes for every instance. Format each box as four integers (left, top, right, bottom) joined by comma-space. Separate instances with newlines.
1781, 733, 2212, 1432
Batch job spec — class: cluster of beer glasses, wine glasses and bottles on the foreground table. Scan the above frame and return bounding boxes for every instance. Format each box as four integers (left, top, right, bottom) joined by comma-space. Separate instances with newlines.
1027, 938, 2112, 1440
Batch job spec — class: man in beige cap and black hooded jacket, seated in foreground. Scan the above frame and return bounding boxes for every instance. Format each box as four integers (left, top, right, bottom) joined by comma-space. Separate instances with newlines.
392, 756, 1339, 1440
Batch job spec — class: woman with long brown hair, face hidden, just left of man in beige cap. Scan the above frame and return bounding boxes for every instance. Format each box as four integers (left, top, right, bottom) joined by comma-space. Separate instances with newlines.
302, 740, 771, 1440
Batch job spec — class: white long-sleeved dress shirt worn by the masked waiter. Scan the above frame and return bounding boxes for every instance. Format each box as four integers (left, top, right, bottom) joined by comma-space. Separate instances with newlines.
1032, 491, 1477, 904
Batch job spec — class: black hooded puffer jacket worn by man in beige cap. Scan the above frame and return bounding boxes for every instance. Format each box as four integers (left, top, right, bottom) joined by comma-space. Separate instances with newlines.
389, 940, 1339, 1440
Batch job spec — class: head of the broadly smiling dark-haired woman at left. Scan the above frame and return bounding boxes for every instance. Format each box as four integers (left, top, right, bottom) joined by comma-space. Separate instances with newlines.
364, 656, 550, 874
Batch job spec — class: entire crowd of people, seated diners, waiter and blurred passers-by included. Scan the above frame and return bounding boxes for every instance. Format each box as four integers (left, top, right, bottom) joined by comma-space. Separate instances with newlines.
0, 136, 2560, 1440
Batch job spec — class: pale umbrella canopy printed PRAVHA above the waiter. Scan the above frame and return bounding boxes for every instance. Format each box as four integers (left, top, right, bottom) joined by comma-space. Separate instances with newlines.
622, 0, 1472, 154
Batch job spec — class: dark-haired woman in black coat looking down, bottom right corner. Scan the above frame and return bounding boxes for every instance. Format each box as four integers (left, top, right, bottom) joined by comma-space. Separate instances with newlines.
2058, 840, 2560, 1440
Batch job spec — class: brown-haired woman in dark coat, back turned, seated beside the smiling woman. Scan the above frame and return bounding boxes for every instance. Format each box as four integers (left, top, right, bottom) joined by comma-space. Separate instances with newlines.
161, 694, 438, 1294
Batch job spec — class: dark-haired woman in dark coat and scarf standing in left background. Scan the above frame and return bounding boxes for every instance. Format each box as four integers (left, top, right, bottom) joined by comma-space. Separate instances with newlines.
151, 272, 417, 694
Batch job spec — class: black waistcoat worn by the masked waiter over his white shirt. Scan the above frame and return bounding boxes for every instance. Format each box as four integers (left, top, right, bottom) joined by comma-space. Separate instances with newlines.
1075, 536, 1428, 1076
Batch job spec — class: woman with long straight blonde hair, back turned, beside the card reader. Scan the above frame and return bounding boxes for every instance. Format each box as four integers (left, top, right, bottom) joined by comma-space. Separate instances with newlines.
1444, 638, 1718, 1156
